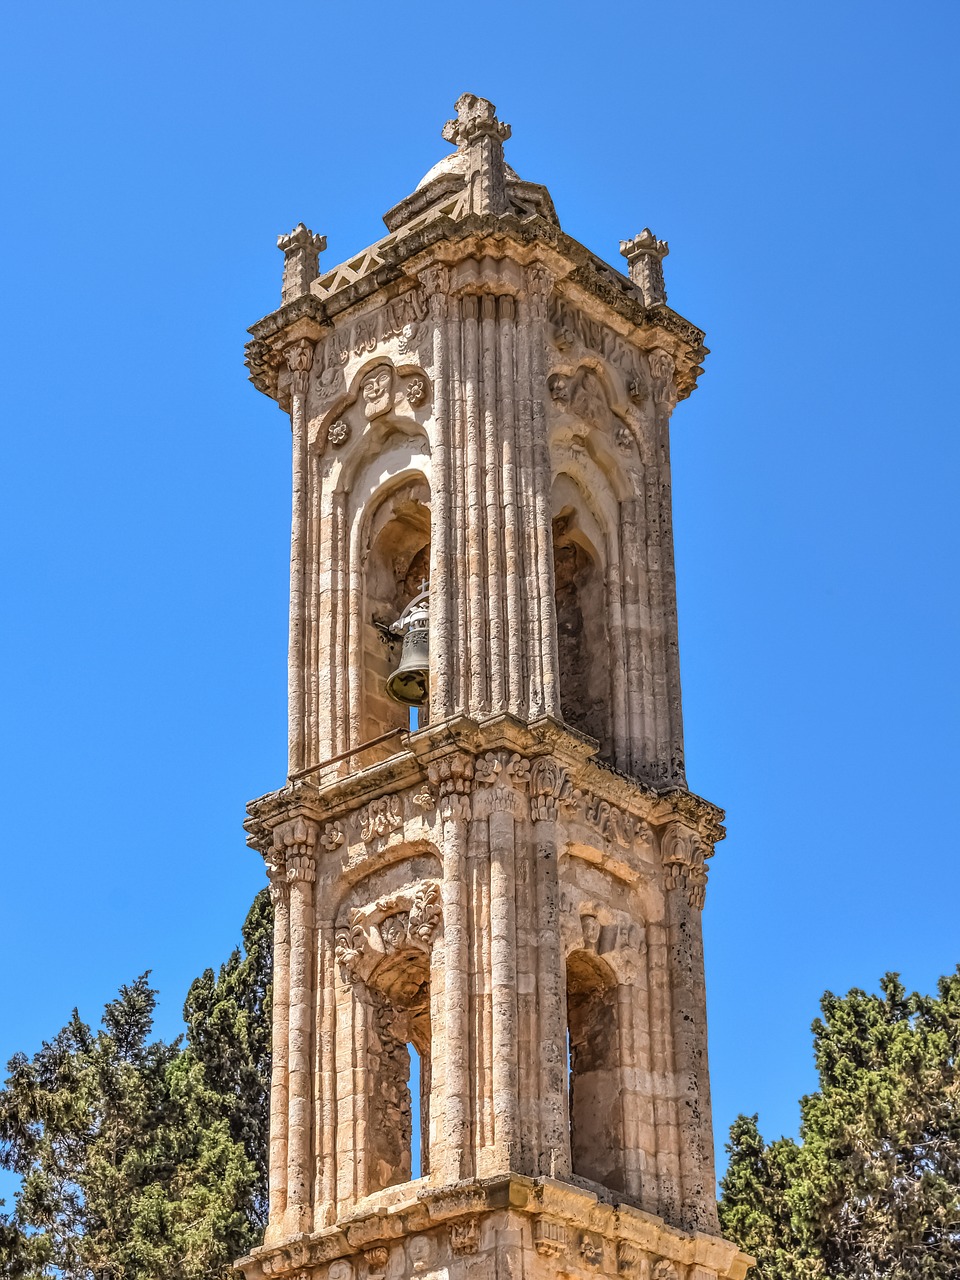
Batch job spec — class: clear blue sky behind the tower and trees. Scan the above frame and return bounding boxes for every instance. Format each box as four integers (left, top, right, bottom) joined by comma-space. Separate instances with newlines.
0, 0, 960, 1182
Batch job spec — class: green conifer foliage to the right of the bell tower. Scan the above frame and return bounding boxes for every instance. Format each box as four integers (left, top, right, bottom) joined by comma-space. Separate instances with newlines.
719, 969, 960, 1280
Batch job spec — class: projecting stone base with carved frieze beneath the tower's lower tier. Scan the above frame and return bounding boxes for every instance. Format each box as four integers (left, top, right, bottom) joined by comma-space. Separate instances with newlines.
236, 1174, 753, 1280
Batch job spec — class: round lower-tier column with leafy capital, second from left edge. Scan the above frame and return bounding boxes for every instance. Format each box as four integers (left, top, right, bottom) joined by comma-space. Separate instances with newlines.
274, 818, 317, 1235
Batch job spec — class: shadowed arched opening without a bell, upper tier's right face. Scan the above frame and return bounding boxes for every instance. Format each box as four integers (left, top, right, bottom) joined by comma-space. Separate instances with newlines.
553, 507, 613, 759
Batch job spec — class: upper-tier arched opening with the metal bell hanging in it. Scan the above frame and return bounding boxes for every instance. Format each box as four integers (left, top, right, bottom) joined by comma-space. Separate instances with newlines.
360, 476, 430, 755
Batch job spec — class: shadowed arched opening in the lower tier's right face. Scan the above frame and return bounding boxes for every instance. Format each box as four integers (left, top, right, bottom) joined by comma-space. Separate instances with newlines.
567, 951, 625, 1190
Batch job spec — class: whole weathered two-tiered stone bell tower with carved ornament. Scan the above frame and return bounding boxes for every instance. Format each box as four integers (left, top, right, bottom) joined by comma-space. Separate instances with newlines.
238, 95, 749, 1280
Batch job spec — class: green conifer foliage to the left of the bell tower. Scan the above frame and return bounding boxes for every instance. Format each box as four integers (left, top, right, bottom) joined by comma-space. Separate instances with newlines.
0, 892, 273, 1280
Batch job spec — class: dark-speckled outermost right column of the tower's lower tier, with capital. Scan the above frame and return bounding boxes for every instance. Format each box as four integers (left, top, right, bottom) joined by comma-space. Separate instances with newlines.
660, 822, 719, 1234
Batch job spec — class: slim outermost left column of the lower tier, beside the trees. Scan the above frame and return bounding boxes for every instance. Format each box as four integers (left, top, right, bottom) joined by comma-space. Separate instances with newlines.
265, 849, 291, 1244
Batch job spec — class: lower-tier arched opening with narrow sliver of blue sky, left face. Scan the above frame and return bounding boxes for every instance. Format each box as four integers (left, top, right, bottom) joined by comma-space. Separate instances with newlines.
365, 947, 431, 1192
